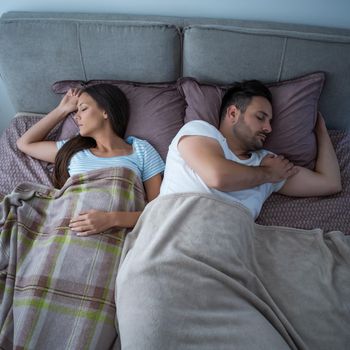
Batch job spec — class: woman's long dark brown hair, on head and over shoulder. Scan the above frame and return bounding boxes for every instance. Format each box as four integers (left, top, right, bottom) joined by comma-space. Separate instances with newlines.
53, 84, 129, 188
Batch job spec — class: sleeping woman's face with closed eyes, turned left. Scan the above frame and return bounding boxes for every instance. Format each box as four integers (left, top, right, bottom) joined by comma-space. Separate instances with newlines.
74, 92, 107, 137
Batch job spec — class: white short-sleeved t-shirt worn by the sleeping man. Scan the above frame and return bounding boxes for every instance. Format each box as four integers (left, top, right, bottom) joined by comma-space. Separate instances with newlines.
160, 120, 284, 219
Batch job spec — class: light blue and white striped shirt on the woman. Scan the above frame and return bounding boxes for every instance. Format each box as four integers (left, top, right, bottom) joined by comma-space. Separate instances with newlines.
56, 136, 164, 182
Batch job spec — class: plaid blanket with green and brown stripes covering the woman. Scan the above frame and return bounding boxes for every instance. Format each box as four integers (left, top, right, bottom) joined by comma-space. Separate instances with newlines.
0, 168, 145, 350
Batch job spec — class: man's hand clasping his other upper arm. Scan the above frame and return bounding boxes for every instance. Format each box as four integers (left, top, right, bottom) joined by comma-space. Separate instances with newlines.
260, 154, 298, 183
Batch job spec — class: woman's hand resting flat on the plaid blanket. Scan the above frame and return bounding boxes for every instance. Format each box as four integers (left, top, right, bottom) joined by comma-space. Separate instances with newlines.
69, 209, 114, 236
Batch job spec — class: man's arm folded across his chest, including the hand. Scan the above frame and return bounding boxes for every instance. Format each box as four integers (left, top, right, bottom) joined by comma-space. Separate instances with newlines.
178, 136, 297, 192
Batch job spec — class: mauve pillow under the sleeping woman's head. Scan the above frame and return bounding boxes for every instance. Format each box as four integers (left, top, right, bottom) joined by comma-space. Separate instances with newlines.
52, 80, 185, 160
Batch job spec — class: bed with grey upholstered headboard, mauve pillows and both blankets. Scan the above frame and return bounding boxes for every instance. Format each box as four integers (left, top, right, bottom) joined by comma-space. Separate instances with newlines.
0, 12, 350, 349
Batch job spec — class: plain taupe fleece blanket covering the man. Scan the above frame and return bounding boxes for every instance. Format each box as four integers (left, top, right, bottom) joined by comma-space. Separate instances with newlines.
116, 194, 350, 350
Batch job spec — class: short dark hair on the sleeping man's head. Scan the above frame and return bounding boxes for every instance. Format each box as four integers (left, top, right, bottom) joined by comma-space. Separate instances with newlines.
220, 80, 272, 120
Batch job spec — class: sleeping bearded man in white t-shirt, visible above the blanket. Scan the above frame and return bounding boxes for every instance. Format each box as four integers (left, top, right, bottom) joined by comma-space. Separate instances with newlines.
160, 80, 341, 218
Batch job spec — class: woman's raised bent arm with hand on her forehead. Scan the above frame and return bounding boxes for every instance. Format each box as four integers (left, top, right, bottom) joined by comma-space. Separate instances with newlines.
17, 89, 80, 163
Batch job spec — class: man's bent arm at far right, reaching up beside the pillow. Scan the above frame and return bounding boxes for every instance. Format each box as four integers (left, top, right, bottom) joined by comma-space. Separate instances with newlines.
279, 113, 342, 197
